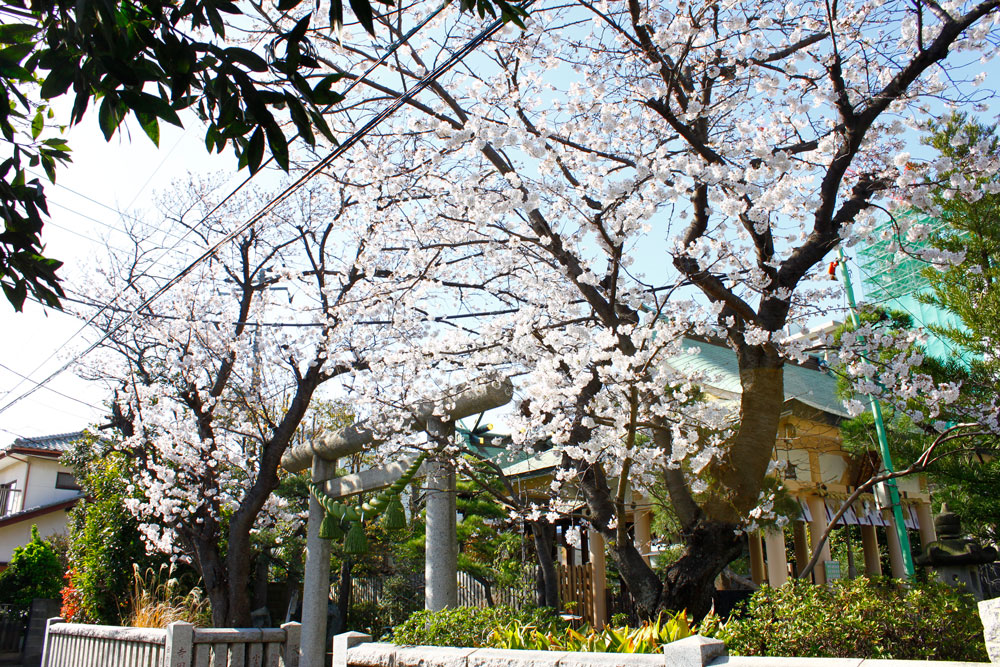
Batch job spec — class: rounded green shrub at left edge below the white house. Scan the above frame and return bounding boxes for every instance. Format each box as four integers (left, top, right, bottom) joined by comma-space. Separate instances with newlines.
0, 526, 63, 614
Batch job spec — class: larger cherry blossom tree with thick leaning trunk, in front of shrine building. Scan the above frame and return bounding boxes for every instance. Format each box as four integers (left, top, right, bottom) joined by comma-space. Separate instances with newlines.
254, 0, 1000, 615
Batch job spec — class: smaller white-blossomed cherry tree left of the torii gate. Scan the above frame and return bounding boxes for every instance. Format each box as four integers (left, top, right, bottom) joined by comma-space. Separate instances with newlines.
71, 181, 450, 626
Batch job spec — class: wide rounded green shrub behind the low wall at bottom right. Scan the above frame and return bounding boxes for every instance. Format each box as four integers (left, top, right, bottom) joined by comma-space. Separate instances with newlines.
716, 577, 988, 662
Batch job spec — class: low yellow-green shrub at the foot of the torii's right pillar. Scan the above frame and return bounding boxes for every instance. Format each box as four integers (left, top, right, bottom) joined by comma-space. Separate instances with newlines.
390, 605, 566, 647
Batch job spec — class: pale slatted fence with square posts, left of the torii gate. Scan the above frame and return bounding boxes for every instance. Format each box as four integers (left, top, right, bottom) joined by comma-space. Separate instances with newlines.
41, 618, 300, 667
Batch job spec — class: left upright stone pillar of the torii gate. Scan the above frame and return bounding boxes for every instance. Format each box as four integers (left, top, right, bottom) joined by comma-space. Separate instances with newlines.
299, 456, 336, 667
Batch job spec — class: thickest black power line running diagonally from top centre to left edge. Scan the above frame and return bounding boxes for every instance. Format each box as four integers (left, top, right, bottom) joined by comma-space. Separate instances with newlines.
0, 7, 533, 414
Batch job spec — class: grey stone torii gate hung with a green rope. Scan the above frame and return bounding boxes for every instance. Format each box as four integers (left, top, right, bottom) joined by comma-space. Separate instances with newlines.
281, 380, 513, 667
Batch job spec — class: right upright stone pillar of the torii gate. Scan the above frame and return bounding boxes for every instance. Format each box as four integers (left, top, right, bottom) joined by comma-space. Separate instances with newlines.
424, 418, 458, 611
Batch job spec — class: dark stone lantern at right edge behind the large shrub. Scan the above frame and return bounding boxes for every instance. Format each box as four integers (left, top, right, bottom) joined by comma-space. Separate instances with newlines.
915, 504, 997, 600
